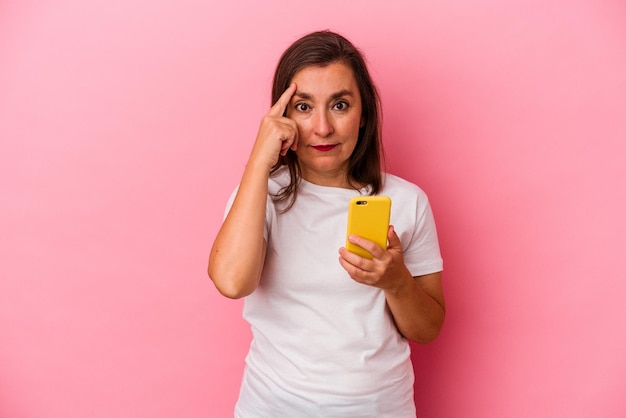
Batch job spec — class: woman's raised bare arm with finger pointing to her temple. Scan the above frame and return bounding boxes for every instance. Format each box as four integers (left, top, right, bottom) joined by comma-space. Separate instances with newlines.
208, 84, 298, 299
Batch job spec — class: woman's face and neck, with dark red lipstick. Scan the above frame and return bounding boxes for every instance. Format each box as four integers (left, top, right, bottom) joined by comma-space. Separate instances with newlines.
287, 62, 362, 188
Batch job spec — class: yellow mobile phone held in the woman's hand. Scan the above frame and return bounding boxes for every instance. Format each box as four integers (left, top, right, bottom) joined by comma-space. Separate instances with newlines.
346, 196, 391, 259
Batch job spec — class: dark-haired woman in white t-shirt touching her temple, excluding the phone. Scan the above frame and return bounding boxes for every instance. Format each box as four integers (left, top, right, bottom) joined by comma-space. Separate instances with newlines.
209, 31, 445, 418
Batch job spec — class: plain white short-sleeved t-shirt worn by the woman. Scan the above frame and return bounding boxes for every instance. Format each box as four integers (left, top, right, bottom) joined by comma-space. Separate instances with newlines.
228, 169, 443, 418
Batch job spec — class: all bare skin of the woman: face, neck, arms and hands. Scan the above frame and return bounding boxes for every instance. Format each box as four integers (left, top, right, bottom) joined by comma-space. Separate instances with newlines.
208, 63, 445, 343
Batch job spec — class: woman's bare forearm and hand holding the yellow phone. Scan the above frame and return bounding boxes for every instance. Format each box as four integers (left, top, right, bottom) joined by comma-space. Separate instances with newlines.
339, 226, 446, 344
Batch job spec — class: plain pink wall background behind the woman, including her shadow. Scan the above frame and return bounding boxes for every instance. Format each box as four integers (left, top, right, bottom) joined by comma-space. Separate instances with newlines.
0, 0, 626, 418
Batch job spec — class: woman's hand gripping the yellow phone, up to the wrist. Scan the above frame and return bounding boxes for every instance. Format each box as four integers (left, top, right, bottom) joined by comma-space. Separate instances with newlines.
339, 225, 413, 290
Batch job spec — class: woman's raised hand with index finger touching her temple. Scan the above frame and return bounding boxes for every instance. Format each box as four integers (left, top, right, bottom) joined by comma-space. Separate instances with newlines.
250, 83, 298, 171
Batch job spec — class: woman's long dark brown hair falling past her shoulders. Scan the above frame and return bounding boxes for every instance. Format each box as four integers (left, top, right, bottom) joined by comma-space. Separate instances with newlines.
272, 31, 383, 210
